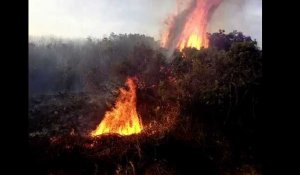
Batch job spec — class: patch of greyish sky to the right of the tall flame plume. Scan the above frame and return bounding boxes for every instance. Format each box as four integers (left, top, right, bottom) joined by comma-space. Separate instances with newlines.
207, 0, 262, 47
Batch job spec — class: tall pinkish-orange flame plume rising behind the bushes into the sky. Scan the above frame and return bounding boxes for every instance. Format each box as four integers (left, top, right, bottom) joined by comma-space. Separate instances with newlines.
161, 0, 222, 50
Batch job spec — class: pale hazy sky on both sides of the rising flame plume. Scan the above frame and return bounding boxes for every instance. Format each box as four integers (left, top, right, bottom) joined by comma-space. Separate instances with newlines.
29, 0, 262, 43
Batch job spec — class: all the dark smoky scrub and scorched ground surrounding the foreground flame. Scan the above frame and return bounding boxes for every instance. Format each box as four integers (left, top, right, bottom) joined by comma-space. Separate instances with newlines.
29, 30, 263, 174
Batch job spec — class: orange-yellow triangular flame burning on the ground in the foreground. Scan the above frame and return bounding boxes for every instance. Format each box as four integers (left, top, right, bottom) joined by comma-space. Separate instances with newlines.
91, 78, 143, 137
